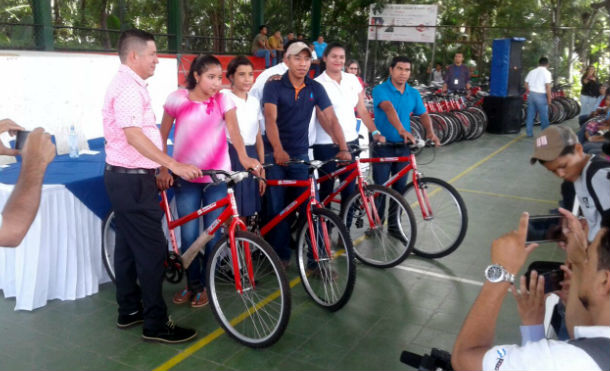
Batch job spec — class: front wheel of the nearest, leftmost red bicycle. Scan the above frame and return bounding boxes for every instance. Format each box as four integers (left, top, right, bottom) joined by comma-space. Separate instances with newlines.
207, 231, 291, 348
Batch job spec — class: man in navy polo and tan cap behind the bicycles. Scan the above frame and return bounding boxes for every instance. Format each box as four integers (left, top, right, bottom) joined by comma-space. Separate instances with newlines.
263, 42, 351, 267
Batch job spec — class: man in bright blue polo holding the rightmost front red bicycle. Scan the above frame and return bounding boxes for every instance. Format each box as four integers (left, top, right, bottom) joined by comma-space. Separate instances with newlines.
373, 56, 441, 194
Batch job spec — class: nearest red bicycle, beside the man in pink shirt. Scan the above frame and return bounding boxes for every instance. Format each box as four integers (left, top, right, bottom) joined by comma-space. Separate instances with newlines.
102, 170, 291, 348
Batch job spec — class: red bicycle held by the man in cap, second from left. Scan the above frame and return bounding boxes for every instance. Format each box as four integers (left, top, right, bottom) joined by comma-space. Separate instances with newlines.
260, 160, 356, 311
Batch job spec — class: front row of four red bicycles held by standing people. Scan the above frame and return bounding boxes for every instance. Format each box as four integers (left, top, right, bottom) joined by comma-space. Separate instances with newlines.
102, 141, 468, 348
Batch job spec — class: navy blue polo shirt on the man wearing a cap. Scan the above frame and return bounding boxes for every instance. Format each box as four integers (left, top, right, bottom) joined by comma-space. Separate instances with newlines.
263, 72, 331, 157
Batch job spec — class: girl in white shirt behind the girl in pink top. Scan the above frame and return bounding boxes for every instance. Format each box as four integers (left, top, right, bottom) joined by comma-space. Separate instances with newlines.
222, 56, 265, 217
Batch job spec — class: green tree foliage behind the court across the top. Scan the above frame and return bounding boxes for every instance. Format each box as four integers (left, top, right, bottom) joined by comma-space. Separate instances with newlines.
0, 0, 610, 91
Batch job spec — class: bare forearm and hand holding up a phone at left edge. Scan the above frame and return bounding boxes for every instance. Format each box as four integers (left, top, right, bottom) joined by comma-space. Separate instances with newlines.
0, 119, 55, 247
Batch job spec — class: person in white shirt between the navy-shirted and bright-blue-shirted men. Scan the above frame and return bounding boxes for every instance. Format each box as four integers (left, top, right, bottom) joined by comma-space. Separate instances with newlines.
313, 43, 385, 212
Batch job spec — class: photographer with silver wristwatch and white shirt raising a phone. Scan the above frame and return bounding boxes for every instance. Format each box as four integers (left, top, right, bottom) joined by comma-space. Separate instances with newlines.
451, 209, 610, 370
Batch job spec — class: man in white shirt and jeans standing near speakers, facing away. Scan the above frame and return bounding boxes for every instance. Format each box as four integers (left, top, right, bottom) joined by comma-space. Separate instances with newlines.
525, 57, 553, 137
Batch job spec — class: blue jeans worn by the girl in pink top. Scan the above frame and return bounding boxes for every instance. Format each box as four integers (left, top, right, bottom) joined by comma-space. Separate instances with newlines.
175, 179, 227, 292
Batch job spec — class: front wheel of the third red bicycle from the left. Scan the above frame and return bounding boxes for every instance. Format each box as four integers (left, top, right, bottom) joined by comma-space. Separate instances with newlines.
341, 184, 417, 268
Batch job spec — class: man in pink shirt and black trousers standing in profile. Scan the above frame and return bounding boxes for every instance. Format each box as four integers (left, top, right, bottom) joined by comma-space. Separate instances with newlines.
102, 29, 201, 343
